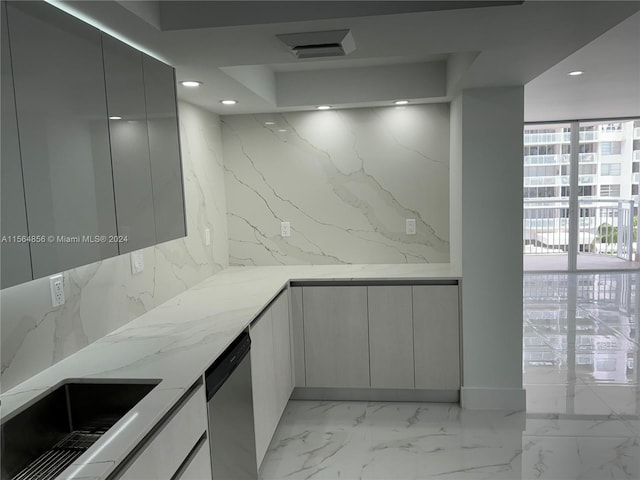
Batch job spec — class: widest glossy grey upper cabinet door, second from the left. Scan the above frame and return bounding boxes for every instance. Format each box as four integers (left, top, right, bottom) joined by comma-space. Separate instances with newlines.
7, 2, 118, 278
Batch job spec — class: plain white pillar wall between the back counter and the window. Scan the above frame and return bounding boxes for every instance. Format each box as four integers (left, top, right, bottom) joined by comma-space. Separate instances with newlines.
452, 87, 525, 410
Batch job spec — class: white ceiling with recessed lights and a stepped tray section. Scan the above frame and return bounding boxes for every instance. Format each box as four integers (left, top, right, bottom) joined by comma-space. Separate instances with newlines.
50, 0, 640, 120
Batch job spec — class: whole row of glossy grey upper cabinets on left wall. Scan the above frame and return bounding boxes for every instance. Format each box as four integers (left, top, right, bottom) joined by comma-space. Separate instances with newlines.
2, 2, 186, 287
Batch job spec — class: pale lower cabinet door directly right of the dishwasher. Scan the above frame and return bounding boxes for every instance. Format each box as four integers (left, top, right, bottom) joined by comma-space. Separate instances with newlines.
249, 309, 279, 467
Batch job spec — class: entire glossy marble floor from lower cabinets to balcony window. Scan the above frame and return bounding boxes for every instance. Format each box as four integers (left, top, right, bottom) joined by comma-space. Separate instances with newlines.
261, 272, 640, 480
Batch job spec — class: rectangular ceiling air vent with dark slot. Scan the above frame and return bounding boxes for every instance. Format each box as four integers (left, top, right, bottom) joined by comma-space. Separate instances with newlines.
276, 30, 356, 58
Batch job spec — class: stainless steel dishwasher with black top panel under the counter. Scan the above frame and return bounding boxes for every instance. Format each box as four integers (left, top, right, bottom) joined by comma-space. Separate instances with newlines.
205, 333, 258, 480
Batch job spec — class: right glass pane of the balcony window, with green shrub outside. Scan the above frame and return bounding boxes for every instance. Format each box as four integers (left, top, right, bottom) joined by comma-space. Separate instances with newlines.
577, 120, 640, 270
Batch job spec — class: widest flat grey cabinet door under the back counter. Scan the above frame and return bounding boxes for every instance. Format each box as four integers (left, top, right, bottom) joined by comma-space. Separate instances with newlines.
303, 286, 370, 388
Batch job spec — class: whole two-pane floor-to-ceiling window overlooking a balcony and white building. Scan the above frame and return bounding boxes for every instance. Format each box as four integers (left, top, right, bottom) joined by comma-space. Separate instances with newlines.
523, 119, 640, 271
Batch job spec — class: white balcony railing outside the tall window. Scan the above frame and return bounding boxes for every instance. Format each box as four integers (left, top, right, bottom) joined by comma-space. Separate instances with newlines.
523, 197, 638, 261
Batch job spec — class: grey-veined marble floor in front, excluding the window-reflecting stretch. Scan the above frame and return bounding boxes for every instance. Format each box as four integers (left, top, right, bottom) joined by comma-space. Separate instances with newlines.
261, 401, 640, 480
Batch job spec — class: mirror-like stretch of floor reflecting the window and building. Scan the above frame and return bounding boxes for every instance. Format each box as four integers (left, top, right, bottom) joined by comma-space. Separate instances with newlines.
523, 272, 640, 416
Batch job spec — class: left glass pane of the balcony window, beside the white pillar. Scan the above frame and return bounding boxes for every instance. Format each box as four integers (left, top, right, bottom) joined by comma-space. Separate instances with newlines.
523, 123, 571, 271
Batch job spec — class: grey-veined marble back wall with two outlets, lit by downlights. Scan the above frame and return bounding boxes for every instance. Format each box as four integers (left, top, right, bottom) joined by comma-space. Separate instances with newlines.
222, 104, 449, 265
